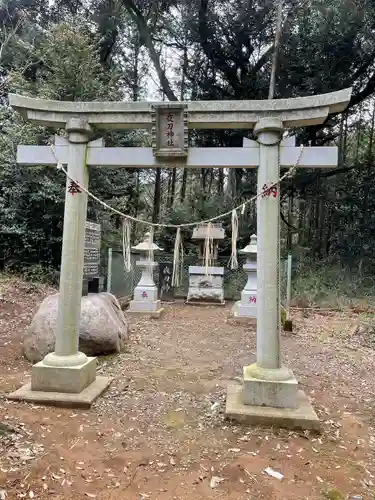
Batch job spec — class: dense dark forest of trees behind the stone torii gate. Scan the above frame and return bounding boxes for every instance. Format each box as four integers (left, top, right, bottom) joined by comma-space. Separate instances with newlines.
0, 0, 375, 302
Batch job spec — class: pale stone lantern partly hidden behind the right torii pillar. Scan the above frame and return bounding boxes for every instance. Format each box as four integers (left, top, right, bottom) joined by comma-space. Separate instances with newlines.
232, 234, 258, 323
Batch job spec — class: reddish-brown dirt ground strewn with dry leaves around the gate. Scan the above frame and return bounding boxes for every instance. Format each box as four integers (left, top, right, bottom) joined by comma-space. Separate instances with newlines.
0, 280, 375, 500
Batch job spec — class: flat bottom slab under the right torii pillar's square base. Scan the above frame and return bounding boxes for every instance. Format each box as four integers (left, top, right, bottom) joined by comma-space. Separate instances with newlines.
225, 384, 320, 432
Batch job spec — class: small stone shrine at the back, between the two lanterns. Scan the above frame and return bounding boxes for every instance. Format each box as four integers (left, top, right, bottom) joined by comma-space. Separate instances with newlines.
186, 224, 225, 304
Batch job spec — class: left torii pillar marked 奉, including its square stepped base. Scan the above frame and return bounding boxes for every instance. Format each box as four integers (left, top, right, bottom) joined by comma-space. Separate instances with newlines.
8, 118, 110, 407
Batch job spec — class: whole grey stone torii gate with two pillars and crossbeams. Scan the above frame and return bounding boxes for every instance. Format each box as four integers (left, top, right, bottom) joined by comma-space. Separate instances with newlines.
10, 89, 351, 427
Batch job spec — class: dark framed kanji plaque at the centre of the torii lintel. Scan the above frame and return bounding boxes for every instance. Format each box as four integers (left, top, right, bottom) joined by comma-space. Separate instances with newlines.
151, 103, 188, 158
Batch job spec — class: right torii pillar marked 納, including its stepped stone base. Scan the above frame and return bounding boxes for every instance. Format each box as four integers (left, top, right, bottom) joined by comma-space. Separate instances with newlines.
226, 93, 354, 430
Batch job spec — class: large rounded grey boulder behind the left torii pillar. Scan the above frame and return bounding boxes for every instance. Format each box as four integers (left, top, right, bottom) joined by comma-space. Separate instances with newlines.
23, 293, 129, 363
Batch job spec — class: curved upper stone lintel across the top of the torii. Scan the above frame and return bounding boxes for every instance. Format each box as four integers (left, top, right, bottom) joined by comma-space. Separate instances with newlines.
9, 88, 352, 129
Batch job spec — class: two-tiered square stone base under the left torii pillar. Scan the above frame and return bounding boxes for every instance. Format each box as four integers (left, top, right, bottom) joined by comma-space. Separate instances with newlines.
8, 358, 111, 408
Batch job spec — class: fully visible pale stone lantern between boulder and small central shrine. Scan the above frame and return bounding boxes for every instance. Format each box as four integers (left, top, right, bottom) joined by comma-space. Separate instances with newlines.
128, 233, 163, 318
